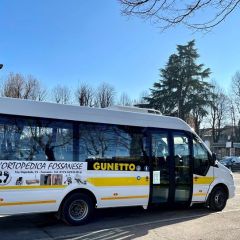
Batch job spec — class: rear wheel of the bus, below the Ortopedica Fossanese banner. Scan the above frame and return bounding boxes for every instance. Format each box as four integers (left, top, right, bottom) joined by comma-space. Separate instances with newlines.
61, 193, 95, 226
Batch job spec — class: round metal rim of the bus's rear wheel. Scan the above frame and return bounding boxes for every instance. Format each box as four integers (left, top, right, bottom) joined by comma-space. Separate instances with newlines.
69, 200, 88, 221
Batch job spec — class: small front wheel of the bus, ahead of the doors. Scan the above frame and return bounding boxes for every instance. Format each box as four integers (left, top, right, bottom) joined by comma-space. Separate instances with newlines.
209, 187, 228, 211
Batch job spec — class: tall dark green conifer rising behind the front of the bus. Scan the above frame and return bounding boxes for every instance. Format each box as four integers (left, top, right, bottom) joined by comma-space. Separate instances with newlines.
145, 41, 212, 130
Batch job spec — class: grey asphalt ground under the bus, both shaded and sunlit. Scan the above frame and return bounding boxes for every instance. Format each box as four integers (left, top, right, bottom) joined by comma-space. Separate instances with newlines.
0, 173, 240, 240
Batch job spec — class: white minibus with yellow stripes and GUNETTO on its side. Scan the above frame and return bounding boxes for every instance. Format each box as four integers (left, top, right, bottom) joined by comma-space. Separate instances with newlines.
0, 98, 235, 225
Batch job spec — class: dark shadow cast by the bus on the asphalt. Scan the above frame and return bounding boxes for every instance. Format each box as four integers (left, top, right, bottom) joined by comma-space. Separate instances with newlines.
0, 206, 211, 240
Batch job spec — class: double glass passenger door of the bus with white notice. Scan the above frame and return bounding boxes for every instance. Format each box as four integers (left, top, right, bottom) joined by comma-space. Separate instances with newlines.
151, 130, 192, 204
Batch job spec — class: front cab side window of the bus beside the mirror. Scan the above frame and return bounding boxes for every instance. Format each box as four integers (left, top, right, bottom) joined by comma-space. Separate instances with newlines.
193, 139, 210, 176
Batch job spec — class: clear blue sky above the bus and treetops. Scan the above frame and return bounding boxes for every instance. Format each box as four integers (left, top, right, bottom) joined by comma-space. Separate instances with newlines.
0, 0, 240, 98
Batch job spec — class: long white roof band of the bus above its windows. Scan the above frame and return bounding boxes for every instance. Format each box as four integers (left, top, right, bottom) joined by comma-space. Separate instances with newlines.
0, 97, 193, 132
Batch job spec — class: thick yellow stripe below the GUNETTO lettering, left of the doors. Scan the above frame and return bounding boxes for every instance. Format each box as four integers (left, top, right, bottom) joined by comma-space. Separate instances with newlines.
87, 177, 149, 187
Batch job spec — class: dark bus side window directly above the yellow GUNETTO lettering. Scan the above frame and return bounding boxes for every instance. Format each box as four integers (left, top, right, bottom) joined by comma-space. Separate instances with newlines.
79, 123, 148, 162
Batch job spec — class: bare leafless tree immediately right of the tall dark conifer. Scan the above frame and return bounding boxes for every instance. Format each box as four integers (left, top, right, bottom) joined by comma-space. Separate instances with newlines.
209, 82, 231, 143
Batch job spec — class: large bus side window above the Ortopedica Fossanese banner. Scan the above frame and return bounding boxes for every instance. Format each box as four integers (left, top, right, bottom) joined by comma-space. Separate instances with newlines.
0, 116, 73, 161
